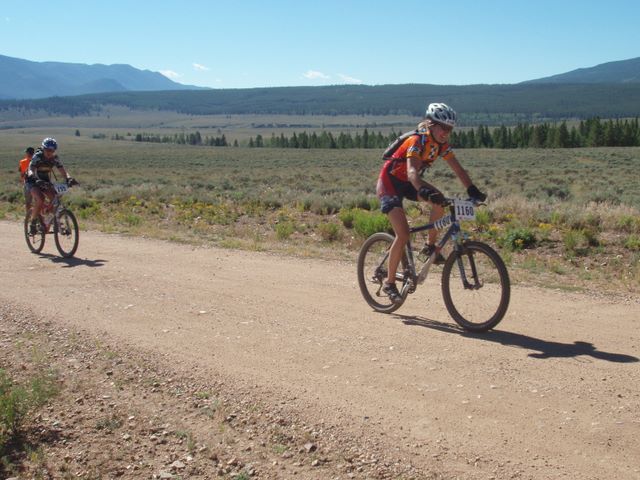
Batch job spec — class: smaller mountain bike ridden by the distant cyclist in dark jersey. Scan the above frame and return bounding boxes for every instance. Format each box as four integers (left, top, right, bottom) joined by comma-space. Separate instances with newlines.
24, 183, 80, 258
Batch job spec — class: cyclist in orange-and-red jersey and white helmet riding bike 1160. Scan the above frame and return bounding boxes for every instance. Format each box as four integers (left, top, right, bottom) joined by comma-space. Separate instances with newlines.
376, 103, 487, 302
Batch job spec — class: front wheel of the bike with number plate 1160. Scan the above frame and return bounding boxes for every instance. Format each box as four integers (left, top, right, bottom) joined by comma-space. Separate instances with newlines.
442, 242, 511, 332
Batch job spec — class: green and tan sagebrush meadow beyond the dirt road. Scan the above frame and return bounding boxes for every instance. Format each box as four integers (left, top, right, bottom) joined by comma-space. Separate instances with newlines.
0, 122, 640, 292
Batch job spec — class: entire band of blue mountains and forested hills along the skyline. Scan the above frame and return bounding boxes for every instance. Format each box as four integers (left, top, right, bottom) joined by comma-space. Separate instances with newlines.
0, 56, 640, 124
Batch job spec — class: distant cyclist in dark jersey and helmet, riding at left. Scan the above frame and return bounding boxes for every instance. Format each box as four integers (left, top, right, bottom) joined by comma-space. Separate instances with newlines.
27, 138, 77, 223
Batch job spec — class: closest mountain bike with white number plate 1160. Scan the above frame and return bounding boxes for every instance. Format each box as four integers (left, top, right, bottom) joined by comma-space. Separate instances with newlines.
358, 198, 511, 332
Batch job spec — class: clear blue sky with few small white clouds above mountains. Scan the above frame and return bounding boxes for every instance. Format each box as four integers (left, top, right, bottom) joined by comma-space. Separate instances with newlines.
0, 0, 640, 88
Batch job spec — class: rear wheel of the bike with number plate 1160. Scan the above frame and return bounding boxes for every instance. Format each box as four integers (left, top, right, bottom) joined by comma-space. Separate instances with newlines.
358, 232, 407, 313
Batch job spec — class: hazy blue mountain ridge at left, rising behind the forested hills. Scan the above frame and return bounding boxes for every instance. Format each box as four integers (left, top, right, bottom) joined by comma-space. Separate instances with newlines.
0, 55, 201, 99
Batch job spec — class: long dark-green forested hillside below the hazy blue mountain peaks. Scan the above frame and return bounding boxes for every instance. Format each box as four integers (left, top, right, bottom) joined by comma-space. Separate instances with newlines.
0, 83, 640, 121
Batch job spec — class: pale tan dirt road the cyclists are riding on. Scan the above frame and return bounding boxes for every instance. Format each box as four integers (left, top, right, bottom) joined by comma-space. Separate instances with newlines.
0, 221, 640, 479
